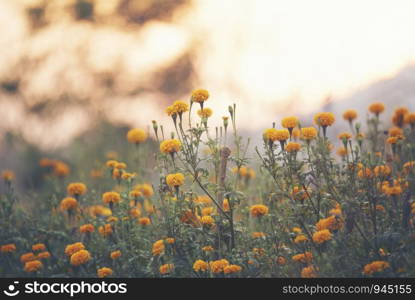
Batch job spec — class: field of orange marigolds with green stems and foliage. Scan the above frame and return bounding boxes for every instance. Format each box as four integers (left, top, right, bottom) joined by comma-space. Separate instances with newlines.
0, 89, 415, 278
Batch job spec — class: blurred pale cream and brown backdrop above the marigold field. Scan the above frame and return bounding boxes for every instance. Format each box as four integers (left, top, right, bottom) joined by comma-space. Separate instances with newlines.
0, 0, 415, 188
